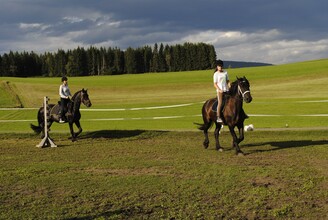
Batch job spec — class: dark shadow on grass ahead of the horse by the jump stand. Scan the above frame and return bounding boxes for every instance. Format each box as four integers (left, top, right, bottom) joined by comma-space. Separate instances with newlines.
78, 130, 166, 139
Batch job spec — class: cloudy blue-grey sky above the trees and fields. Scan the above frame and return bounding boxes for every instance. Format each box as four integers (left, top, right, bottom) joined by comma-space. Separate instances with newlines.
0, 0, 328, 64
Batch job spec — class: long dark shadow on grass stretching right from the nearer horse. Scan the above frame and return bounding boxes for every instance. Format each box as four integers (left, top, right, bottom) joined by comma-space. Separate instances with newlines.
242, 140, 328, 152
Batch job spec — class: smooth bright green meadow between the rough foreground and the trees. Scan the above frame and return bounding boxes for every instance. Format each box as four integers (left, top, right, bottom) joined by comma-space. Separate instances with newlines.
0, 57, 328, 132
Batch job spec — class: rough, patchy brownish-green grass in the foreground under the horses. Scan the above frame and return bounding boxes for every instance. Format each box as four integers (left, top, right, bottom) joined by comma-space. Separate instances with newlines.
0, 130, 328, 219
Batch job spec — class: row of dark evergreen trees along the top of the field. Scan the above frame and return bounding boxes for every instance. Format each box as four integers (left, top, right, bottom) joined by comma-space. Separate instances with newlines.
0, 43, 216, 77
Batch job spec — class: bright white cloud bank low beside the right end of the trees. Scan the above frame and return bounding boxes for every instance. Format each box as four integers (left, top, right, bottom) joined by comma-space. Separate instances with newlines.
174, 29, 328, 64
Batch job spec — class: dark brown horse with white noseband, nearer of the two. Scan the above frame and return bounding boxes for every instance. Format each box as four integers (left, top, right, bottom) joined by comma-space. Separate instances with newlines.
199, 77, 252, 155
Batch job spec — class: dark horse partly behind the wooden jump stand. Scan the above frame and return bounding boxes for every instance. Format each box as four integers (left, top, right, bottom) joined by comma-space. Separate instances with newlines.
31, 89, 91, 141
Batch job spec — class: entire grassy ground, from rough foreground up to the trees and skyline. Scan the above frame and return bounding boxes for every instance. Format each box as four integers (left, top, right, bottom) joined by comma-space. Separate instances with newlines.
0, 60, 328, 219
